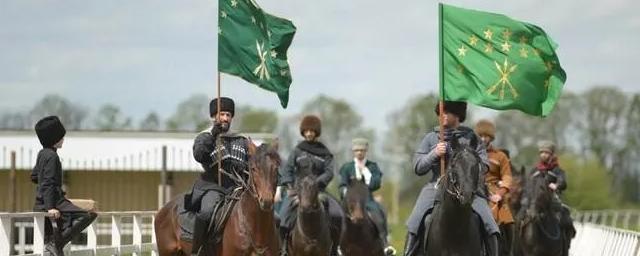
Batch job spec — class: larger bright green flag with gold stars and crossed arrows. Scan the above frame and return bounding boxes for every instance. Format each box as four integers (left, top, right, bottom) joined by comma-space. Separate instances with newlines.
440, 4, 566, 116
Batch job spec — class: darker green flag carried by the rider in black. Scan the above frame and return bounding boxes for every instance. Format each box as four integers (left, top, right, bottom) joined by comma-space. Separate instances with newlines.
218, 0, 296, 108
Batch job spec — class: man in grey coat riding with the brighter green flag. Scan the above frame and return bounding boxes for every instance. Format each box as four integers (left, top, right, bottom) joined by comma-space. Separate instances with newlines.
404, 101, 500, 256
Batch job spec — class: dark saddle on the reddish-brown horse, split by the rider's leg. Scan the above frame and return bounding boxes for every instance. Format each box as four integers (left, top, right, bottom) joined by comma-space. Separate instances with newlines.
177, 188, 244, 244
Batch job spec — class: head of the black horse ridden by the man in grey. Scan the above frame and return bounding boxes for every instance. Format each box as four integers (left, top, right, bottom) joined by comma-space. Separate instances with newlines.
444, 140, 482, 205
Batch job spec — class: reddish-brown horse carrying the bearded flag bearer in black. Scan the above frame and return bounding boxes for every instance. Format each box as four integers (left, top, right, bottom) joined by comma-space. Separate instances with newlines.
154, 143, 280, 256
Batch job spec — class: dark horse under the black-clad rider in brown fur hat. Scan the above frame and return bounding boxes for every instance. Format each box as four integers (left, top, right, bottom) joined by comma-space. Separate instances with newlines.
287, 175, 333, 256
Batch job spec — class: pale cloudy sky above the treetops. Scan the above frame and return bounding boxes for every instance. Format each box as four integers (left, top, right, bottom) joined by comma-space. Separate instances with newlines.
0, 0, 640, 132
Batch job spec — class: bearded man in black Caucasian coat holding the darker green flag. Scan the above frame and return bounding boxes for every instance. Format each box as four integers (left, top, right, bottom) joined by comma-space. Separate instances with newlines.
185, 97, 249, 254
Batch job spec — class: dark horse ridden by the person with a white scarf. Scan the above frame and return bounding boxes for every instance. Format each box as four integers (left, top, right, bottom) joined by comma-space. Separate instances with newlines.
340, 179, 384, 256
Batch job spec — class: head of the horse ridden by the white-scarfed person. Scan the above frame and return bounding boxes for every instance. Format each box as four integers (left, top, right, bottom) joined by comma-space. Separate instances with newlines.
343, 179, 369, 223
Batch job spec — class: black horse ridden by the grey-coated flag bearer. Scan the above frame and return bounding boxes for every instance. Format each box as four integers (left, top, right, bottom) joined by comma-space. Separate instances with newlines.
423, 145, 485, 256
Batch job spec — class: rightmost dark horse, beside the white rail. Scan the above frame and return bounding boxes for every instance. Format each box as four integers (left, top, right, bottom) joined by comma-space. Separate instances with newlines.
518, 172, 569, 256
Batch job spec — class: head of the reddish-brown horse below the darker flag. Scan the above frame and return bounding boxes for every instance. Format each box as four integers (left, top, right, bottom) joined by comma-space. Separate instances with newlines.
249, 142, 281, 211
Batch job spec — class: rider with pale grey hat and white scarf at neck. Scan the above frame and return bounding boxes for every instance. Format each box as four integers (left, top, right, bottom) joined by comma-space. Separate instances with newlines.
340, 138, 396, 255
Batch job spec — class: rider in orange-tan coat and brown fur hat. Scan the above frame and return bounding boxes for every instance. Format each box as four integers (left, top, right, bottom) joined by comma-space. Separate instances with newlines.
475, 119, 514, 255
